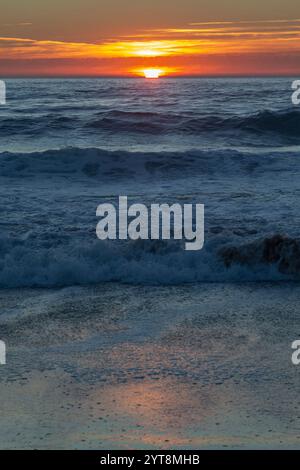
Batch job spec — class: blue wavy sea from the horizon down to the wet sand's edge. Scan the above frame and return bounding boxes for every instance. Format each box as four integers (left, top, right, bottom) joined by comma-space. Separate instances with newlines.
0, 78, 300, 287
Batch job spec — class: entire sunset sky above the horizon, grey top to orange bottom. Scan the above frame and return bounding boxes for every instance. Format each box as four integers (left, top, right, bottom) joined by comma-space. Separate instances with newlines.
0, 0, 300, 78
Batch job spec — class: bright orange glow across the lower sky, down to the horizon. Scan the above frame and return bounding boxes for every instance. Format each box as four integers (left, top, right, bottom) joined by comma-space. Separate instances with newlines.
0, 19, 300, 78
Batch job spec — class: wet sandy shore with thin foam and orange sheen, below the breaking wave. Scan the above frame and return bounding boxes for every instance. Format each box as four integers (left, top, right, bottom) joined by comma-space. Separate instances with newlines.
0, 283, 300, 449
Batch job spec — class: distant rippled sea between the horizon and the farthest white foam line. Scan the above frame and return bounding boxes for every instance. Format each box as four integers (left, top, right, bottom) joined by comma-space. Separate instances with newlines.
0, 78, 300, 152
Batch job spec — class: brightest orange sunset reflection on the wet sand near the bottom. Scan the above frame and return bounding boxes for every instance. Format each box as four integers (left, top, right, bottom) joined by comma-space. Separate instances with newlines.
88, 378, 218, 445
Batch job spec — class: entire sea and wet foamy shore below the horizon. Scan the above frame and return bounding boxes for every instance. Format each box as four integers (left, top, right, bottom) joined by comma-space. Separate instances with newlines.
0, 77, 300, 450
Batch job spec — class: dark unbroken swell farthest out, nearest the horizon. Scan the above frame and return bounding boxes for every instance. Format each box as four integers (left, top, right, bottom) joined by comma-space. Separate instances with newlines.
0, 109, 300, 140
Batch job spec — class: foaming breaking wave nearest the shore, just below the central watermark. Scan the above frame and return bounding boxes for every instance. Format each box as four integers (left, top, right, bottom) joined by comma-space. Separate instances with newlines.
0, 233, 300, 288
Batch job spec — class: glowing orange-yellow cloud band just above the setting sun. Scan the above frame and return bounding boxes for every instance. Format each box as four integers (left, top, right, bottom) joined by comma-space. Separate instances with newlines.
0, 19, 300, 73
